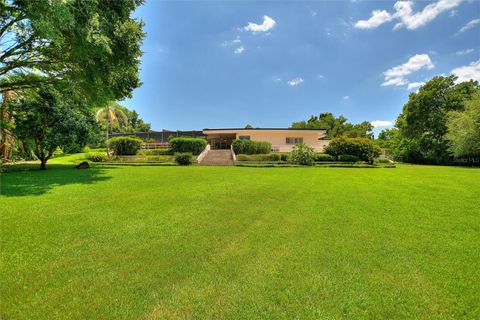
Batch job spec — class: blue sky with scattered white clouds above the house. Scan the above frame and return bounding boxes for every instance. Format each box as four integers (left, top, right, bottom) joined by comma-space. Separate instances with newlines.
125, 0, 480, 132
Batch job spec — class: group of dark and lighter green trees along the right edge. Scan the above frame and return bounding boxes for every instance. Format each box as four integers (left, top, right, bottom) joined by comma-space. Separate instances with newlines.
377, 76, 480, 164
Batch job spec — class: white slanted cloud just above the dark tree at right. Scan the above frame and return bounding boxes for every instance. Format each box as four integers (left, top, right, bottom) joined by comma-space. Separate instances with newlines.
382, 54, 434, 86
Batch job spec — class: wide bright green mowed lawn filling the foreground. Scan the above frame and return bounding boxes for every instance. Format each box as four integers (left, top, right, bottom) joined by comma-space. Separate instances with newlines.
0, 165, 480, 319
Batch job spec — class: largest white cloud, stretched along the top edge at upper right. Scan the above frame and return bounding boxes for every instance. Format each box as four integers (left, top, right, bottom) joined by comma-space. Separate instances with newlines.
355, 0, 463, 30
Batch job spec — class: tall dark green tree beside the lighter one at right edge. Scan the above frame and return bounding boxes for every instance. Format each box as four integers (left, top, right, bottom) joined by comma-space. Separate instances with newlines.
396, 76, 479, 164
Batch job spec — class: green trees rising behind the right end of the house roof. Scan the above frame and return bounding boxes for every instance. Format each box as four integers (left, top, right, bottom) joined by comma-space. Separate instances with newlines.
292, 112, 373, 139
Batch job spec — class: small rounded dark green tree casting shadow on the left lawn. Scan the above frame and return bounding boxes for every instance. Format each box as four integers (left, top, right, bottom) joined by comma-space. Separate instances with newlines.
9, 85, 97, 170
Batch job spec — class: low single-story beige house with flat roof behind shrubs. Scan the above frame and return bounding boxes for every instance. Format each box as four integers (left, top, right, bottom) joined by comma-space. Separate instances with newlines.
203, 128, 329, 152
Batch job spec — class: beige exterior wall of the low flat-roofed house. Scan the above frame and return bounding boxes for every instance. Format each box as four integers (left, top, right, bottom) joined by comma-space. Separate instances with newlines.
204, 129, 329, 152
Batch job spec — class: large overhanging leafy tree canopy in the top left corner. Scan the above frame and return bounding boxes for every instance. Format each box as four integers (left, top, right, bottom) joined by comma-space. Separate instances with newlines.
0, 0, 144, 105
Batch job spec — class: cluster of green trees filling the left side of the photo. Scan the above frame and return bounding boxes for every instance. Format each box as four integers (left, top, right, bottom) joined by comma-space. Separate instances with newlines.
0, 0, 149, 168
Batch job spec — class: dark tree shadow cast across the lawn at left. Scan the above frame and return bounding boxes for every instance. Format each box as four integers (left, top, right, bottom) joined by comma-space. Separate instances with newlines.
0, 164, 114, 197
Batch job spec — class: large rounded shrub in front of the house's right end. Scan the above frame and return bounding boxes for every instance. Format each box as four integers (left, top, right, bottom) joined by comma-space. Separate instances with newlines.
325, 136, 381, 163
